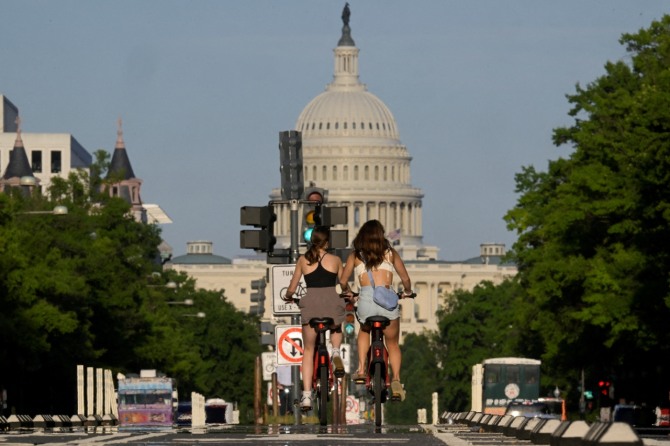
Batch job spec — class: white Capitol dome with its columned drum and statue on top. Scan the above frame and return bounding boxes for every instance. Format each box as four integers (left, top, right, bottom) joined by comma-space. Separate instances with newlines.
270, 5, 437, 260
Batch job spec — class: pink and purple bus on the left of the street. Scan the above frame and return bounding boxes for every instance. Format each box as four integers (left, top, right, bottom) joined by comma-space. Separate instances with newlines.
118, 370, 177, 430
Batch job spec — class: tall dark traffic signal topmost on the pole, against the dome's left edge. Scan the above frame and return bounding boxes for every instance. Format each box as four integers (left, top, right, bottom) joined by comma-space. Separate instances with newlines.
279, 130, 305, 200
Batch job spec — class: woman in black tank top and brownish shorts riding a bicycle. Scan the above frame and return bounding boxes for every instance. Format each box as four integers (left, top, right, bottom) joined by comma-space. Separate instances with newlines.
286, 226, 345, 410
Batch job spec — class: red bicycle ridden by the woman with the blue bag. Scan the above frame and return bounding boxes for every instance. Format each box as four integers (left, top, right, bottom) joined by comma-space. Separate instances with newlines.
346, 291, 416, 426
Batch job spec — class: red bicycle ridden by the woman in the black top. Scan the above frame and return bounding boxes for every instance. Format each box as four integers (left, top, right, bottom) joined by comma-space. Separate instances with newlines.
309, 317, 344, 426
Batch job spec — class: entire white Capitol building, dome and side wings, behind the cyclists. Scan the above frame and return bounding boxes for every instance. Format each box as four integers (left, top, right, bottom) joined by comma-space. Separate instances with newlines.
166, 9, 517, 336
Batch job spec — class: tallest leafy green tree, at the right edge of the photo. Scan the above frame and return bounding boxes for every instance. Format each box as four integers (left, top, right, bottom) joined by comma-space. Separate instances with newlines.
506, 16, 670, 404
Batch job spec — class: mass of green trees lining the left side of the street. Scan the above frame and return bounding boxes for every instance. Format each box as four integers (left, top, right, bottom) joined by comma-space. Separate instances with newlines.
0, 164, 261, 421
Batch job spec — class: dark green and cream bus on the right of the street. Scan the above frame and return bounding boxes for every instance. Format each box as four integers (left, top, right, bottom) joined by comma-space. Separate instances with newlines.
472, 358, 541, 415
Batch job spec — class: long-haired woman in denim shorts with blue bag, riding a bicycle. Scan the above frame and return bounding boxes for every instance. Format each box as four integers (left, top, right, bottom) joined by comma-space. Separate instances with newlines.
340, 220, 412, 400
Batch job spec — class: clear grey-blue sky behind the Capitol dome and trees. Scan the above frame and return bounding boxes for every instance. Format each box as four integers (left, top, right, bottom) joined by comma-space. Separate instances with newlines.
0, 0, 670, 260
